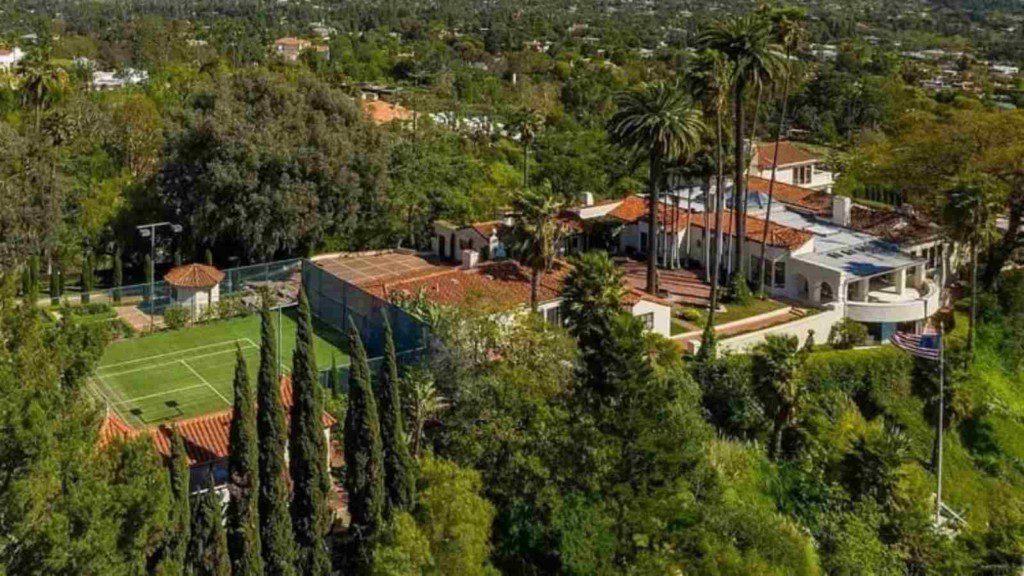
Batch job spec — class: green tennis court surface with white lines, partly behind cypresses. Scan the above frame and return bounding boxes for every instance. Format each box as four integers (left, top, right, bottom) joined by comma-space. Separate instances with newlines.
90, 308, 348, 426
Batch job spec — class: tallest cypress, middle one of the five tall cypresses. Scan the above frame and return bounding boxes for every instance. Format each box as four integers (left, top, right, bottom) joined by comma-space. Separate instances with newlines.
288, 289, 331, 576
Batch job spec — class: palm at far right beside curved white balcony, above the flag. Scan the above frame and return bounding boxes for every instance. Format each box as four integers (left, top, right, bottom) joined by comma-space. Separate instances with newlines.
942, 173, 1006, 360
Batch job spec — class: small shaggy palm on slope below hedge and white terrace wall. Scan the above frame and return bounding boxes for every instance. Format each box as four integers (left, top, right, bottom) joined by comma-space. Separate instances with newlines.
753, 335, 804, 458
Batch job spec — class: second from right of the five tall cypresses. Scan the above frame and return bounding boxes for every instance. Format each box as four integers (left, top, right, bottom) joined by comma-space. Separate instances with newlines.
345, 320, 385, 568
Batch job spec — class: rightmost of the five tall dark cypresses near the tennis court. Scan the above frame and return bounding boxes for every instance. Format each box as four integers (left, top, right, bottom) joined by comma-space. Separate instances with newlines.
377, 313, 416, 520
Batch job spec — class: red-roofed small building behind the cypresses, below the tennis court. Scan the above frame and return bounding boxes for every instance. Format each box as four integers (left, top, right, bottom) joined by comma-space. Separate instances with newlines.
99, 376, 340, 501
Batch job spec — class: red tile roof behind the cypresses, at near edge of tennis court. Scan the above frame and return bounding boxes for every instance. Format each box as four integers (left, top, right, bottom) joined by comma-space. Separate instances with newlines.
99, 376, 337, 466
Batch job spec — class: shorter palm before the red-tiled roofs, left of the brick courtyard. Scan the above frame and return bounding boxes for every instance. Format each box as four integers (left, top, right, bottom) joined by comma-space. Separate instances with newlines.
512, 182, 565, 312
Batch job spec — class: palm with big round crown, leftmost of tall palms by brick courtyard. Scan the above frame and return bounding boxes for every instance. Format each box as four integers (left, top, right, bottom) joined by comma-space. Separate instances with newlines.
608, 82, 705, 294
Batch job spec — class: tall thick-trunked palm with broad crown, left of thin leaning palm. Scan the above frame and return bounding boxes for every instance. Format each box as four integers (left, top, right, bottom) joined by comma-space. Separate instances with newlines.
698, 14, 780, 286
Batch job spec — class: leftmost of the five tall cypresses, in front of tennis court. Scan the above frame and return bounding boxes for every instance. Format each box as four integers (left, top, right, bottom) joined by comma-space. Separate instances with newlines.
227, 347, 263, 576
